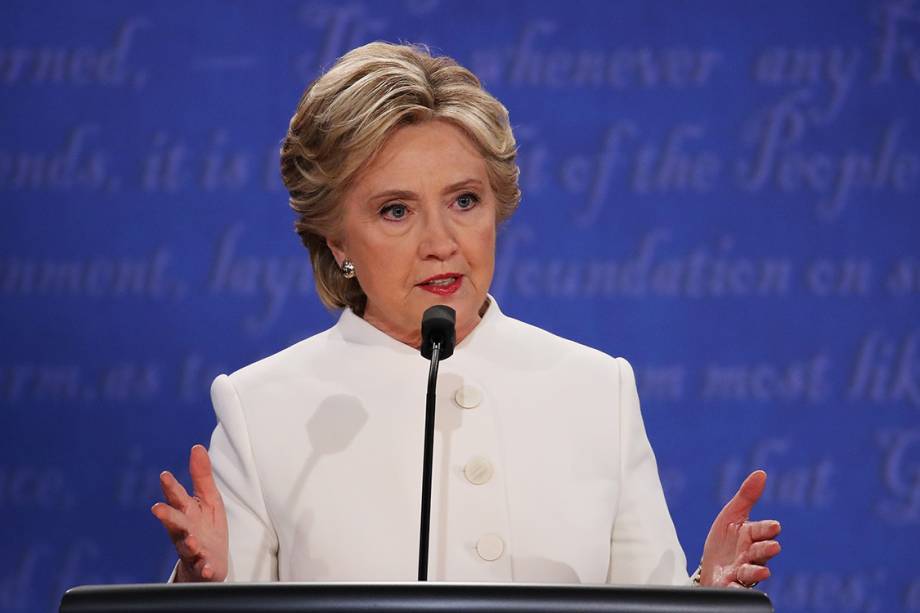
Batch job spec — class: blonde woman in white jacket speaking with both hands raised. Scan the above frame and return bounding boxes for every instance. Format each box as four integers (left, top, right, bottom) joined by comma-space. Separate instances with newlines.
152, 43, 779, 587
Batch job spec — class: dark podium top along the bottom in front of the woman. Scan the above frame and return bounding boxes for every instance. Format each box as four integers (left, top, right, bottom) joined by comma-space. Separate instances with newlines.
60, 582, 773, 613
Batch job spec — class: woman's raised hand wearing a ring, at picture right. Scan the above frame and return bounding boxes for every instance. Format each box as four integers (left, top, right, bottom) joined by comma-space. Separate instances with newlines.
700, 470, 780, 587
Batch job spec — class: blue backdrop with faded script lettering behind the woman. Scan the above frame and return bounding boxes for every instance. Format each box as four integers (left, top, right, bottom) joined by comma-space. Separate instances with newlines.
0, 0, 920, 612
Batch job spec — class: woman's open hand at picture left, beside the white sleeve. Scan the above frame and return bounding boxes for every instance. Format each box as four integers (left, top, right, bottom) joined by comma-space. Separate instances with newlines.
150, 445, 229, 582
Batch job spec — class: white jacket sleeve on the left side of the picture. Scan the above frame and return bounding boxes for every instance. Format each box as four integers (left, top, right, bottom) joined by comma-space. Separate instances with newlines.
209, 375, 278, 582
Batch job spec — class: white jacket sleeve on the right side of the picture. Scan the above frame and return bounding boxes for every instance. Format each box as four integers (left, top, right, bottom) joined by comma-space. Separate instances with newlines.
607, 358, 690, 585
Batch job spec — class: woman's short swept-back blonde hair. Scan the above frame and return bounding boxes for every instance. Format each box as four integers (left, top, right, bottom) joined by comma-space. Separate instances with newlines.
281, 42, 521, 315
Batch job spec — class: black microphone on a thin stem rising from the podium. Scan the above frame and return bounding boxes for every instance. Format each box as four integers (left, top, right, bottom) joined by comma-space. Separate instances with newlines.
418, 304, 457, 581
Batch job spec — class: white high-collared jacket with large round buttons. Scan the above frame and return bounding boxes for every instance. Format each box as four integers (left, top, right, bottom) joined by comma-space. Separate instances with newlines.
203, 299, 688, 585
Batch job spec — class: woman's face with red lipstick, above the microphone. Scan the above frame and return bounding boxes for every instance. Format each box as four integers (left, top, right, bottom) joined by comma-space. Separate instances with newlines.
328, 120, 496, 347
